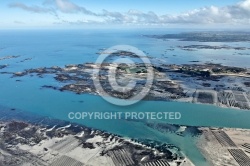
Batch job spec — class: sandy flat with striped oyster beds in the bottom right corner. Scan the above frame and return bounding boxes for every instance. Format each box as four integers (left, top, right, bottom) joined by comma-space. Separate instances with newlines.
197, 127, 250, 166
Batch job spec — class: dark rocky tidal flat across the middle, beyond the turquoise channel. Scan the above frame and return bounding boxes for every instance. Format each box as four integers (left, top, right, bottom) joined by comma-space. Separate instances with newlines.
8, 56, 250, 110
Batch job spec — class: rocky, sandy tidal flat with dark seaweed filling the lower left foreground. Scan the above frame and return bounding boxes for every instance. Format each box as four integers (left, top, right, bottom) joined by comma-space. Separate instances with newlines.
0, 107, 193, 166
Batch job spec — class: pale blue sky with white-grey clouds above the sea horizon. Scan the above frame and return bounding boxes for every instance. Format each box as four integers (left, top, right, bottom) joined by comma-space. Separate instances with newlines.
0, 0, 250, 28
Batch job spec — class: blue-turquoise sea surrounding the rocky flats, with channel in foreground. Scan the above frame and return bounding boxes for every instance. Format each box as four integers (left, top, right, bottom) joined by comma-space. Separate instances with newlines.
0, 29, 250, 165
